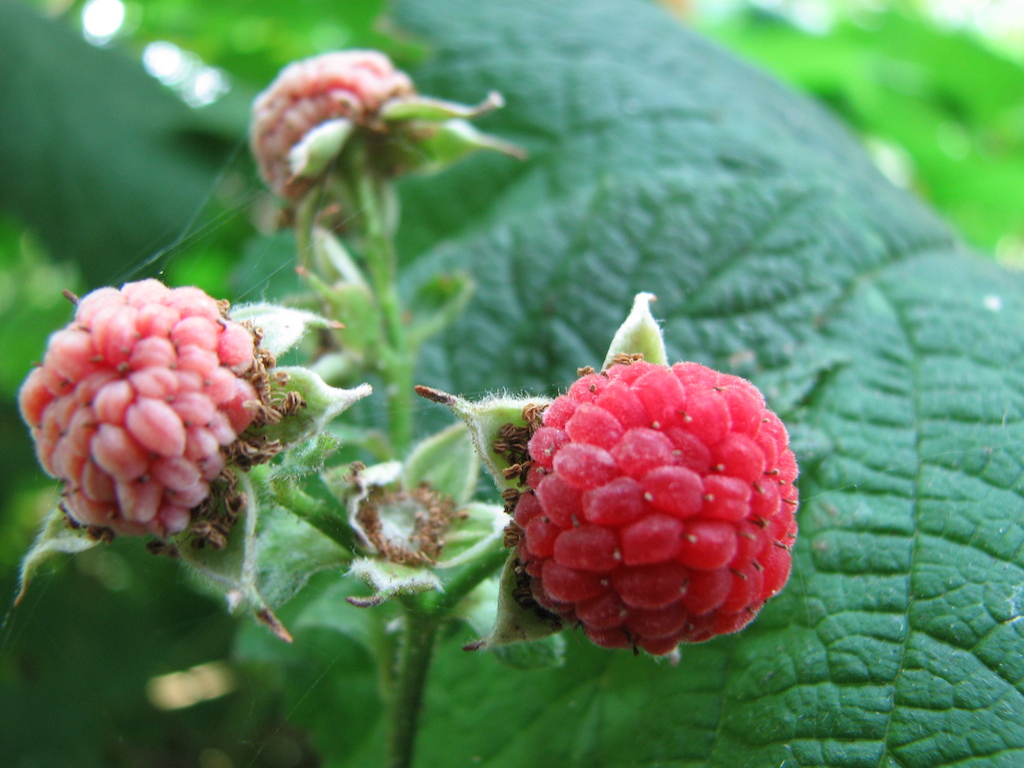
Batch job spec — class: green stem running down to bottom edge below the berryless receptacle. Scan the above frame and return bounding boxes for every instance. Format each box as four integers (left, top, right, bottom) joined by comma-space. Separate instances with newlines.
386, 605, 438, 768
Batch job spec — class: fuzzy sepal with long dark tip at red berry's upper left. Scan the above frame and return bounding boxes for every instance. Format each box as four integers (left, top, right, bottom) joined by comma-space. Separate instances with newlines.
416, 386, 551, 490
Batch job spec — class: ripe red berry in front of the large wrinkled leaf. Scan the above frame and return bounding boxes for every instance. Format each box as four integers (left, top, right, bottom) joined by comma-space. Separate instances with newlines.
516, 361, 798, 655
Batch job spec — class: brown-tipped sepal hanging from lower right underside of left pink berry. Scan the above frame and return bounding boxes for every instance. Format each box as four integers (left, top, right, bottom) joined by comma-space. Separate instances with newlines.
171, 472, 292, 643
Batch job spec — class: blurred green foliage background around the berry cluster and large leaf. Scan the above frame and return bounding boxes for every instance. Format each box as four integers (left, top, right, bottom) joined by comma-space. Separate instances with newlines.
0, 0, 1024, 768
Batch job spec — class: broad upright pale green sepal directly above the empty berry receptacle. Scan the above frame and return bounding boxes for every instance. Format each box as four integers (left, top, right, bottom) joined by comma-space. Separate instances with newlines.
401, 424, 480, 505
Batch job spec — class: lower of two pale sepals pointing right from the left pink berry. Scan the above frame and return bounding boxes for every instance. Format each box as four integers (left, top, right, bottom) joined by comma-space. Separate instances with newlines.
258, 366, 373, 446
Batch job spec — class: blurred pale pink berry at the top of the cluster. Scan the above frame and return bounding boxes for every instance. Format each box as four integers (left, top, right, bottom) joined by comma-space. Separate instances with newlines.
250, 50, 416, 201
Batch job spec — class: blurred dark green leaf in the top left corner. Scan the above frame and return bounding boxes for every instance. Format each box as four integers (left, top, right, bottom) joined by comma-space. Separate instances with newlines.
0, 0, 227, 292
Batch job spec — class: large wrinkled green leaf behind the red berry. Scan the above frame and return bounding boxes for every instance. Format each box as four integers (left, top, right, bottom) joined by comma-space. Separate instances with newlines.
350, 0, 1024, 768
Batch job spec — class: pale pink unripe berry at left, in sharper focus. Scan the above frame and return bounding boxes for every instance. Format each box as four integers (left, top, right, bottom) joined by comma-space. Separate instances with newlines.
18, 280, 258, 537
